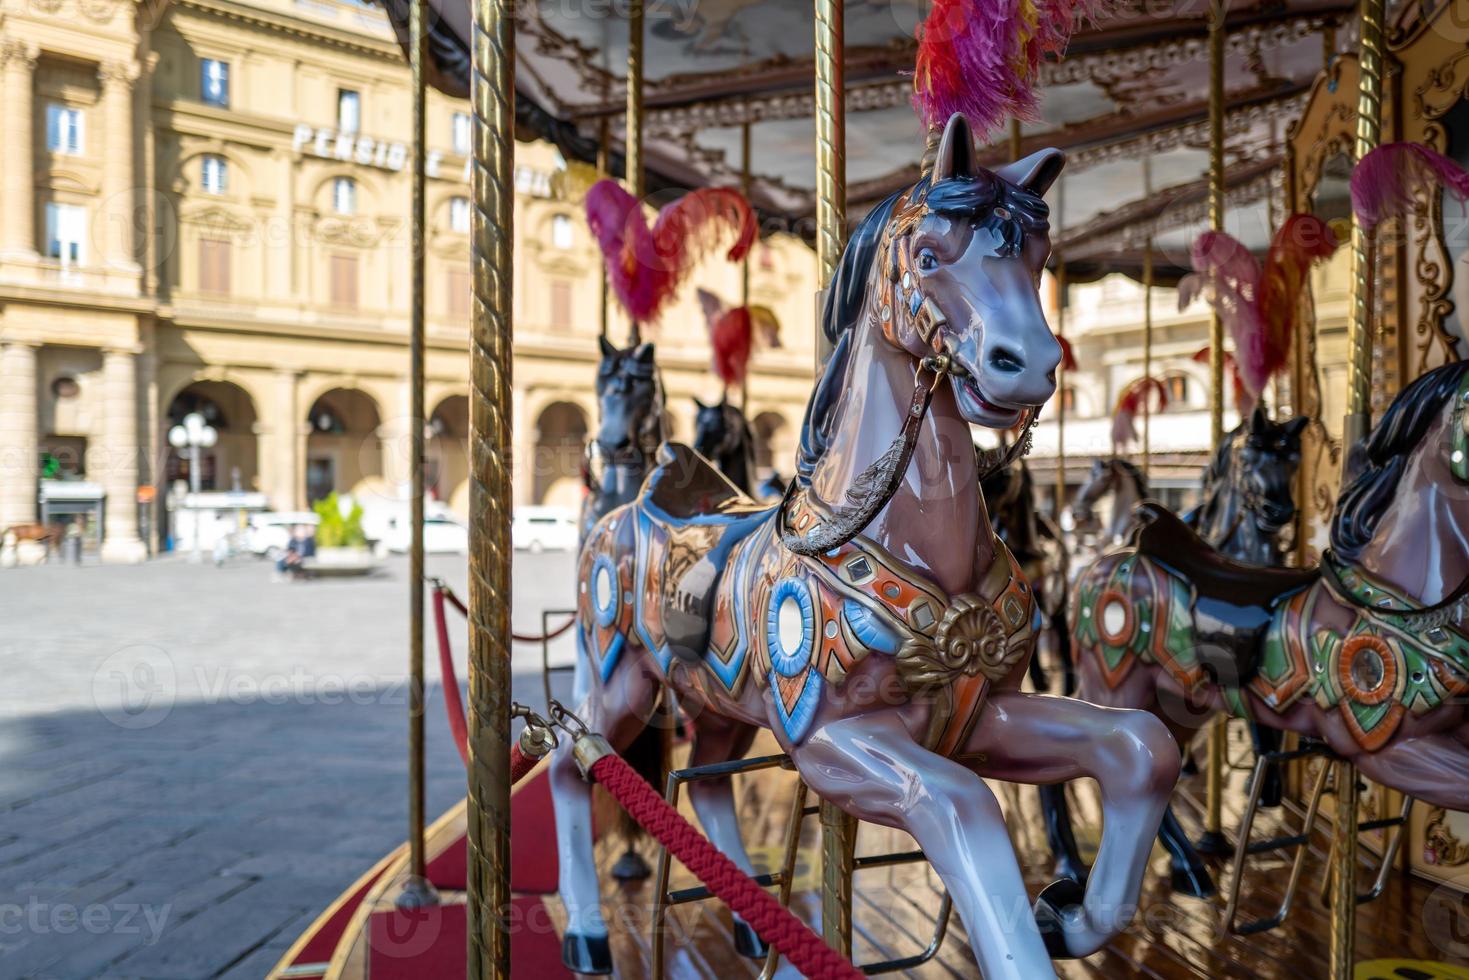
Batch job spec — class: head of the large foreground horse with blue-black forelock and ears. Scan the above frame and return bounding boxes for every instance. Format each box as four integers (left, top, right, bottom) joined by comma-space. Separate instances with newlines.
871, 115, 1065, 429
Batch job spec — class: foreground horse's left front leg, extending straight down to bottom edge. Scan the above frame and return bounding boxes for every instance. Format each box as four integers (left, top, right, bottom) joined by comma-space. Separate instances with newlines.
792, 710, 1055, 980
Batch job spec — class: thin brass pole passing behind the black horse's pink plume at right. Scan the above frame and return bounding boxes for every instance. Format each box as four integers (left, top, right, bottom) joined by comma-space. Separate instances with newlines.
1199, 0, 1228, 854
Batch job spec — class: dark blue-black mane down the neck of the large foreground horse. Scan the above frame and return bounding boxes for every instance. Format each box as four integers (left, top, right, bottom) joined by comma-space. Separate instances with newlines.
796, 191, 903, 486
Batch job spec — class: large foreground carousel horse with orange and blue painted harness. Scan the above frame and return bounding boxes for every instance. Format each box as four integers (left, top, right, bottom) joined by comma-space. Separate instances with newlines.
551, 115, 1178, 980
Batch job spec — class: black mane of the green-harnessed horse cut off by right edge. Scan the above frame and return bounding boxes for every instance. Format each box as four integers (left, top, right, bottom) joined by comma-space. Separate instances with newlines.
1331, 361, 1469, 561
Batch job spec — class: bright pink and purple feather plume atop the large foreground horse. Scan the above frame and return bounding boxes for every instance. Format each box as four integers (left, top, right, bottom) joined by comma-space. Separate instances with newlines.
914, 0, 1105, 140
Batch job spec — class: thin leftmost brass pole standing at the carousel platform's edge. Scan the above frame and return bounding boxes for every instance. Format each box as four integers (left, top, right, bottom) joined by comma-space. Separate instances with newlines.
398, 0, 436, 907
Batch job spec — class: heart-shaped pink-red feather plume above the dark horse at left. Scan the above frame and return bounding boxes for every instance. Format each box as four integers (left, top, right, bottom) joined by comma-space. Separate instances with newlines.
586, 179, 758, 323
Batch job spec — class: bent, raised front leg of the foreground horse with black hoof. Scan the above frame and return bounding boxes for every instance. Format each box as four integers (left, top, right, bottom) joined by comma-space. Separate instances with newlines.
965, 691, 1178, 956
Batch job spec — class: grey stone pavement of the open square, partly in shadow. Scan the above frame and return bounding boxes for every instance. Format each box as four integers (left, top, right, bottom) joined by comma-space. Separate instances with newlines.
0, 554, 584, 980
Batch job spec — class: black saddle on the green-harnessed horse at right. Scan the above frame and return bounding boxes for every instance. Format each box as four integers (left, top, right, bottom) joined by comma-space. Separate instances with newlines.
1134, 501, 1321, 688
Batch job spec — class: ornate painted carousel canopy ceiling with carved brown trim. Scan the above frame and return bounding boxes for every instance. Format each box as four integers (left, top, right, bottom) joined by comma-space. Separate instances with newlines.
386, 0, 1356, 281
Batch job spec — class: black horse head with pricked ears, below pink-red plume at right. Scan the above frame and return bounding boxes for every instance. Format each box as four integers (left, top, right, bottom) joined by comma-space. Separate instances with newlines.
1205, 406, 1309, 544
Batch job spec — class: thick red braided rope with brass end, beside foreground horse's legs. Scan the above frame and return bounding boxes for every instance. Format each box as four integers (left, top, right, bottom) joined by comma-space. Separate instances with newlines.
584, 746, 864, 980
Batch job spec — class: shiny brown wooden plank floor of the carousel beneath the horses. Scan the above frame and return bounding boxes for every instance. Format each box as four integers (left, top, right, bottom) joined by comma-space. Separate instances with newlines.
546, 730, 1469, 980
